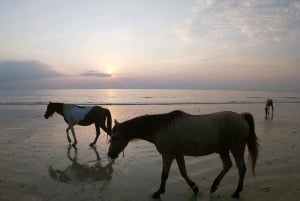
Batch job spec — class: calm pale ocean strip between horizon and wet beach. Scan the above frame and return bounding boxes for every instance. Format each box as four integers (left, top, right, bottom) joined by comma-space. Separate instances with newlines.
0, 89, 300, 105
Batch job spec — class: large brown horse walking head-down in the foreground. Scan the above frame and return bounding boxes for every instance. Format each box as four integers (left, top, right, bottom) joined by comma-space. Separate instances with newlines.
108, 111, 259, 198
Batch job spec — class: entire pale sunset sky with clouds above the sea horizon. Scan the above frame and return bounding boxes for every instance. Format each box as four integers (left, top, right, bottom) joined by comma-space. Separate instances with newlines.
0, 0, 300, 91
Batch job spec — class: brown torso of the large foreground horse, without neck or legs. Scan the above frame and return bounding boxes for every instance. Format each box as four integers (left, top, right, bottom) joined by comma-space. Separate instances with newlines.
157, 111, 249, 156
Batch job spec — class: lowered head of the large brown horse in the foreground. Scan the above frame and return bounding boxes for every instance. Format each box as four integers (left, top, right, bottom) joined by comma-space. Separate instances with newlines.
108, 120, 129, 159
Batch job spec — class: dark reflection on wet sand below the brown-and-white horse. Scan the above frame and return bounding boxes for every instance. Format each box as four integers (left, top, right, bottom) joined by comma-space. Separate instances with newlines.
48, 146, 113, 183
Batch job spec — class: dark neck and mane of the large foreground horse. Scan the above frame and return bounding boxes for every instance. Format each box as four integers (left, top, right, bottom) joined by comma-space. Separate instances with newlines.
121, 110, 186, 140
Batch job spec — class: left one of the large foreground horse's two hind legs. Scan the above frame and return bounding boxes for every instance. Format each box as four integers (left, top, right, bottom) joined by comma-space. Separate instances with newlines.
210, 150, 232, 193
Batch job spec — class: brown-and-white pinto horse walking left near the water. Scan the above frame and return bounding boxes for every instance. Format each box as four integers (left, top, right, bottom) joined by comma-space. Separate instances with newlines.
44, 102, 111, 146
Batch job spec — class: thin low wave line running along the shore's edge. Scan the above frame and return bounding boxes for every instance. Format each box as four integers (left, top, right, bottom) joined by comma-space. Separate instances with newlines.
0, 99, 300, 106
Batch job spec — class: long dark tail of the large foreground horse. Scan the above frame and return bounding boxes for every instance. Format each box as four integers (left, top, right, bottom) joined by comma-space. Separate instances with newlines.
242, 113, 259, 175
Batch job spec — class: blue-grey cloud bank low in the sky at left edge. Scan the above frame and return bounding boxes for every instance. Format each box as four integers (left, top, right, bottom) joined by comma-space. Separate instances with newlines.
0, 61, 64, 82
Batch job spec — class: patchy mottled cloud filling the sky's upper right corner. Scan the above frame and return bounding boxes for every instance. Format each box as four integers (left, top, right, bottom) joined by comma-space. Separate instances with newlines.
172, 0, 300, 42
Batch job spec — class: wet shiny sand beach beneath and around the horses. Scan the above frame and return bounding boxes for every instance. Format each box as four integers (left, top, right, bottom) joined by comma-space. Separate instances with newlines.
0, 104, 300, 201
